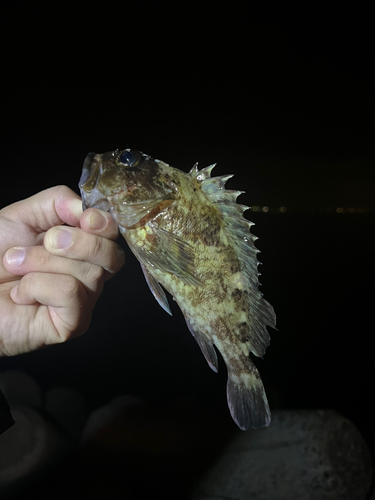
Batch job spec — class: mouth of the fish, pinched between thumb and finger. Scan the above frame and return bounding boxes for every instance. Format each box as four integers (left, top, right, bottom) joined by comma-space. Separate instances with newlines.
78, 153, 111, 212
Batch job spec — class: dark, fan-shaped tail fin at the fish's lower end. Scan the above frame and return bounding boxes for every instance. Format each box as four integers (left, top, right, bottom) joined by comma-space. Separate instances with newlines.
227, 359, 271, 431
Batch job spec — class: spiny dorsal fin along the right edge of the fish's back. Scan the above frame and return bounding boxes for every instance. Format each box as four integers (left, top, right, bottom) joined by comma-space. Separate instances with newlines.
190, 164, 276, 357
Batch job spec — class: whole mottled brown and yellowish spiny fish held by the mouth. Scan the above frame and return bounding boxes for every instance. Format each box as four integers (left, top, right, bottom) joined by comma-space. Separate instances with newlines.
79, 149, 276, 430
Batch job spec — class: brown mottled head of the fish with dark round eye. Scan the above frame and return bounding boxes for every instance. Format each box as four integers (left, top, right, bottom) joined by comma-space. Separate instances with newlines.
78, 149, 179, 227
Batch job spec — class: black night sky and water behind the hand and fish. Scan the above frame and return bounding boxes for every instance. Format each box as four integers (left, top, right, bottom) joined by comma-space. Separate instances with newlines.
0, 2, 375, 488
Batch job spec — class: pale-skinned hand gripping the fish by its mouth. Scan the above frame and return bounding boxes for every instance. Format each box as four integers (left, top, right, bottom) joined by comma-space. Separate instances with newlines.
0, 186, 125, 356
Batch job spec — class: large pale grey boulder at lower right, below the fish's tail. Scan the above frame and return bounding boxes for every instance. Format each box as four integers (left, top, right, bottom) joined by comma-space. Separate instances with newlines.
190, 410, 373, 500
